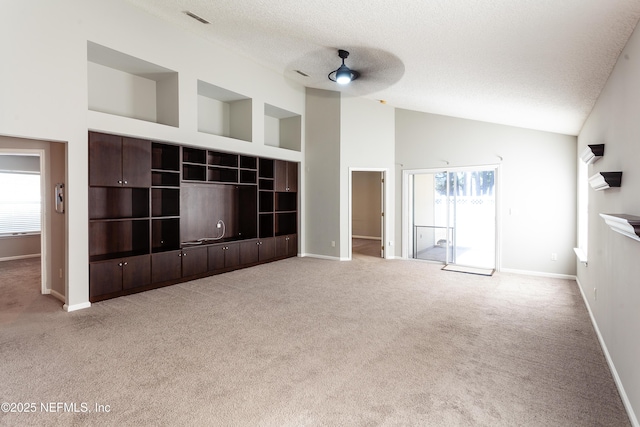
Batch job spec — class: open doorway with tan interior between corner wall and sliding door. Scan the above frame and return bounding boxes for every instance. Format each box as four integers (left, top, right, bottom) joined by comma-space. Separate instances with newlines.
349, 169, 385, 258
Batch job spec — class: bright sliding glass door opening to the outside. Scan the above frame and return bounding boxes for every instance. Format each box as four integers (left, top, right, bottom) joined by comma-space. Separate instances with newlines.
406, 166, 497, 272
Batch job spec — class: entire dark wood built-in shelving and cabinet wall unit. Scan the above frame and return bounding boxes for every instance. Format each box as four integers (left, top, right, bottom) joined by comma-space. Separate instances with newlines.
89, 132, 298, 302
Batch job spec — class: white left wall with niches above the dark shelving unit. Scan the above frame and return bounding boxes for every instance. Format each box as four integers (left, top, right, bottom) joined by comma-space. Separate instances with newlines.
0, 0, 305, 310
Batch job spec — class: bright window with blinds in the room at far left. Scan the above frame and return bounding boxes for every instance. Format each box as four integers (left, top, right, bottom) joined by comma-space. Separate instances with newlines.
0, 171, 41, 236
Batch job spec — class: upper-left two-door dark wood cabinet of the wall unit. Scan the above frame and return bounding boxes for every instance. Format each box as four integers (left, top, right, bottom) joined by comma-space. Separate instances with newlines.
89, 132, 151, 187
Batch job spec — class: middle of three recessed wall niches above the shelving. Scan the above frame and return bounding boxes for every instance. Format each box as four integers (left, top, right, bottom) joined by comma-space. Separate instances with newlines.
198, 80, 253, 142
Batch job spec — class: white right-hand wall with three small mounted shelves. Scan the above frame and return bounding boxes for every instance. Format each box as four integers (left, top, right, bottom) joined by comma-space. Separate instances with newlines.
577, 17, 640, 425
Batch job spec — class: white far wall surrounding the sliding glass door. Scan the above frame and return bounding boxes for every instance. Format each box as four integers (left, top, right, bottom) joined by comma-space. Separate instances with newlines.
396, 109, 576, 276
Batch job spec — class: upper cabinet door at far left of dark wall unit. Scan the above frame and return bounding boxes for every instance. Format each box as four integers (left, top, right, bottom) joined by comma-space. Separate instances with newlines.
89, 132, 122, 187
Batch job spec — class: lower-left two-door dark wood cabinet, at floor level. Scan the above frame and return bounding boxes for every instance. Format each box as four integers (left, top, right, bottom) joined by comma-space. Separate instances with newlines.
89, 255, 151, 298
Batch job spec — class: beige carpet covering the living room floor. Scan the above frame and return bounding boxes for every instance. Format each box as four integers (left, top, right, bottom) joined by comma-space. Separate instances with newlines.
0, 257, 629, 426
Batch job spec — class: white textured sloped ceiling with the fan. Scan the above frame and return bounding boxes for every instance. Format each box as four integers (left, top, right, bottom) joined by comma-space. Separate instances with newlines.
127, 0, 640, 135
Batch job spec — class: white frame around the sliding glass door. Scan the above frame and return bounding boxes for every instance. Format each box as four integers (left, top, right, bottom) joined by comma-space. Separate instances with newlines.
401, 164, 502, 271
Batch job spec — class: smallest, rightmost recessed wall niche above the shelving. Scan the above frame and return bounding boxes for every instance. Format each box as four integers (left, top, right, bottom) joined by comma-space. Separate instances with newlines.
264, 104, 302, 151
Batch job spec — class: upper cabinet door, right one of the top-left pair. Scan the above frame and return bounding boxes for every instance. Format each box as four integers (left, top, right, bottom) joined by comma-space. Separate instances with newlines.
121, 138, 151, 187
